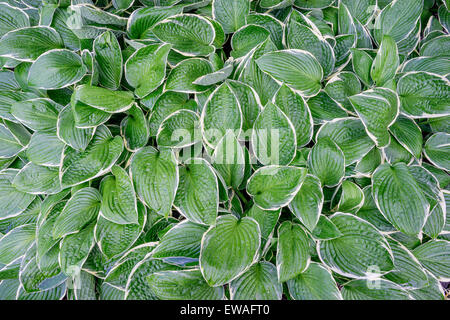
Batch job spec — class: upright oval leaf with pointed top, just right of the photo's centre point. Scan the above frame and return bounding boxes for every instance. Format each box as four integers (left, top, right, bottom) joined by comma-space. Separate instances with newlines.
251, 102, 297, 165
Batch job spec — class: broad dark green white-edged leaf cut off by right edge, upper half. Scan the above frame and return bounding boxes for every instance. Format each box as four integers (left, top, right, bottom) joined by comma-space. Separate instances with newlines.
397, 71, 450, 118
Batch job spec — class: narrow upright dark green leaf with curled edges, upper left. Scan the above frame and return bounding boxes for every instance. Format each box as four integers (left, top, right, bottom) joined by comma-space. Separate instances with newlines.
93, 31, 123, 90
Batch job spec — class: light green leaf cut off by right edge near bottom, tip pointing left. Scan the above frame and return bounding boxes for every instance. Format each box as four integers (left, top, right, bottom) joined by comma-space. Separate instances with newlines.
412, 240, 450, 282
